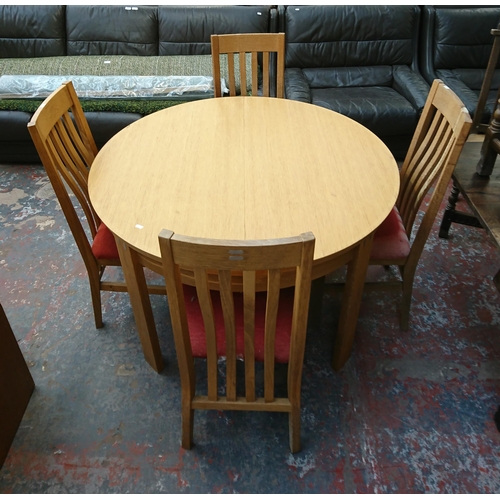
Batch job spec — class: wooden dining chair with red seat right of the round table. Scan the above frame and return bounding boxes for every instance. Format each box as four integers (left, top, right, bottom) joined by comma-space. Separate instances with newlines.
365, 80, 472, 330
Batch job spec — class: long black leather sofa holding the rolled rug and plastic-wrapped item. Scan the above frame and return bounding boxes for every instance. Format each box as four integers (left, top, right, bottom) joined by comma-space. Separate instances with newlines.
0, 5, 276, 163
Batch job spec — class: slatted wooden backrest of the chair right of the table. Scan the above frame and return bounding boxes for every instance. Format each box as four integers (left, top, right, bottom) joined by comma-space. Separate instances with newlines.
396, 80, 472, 260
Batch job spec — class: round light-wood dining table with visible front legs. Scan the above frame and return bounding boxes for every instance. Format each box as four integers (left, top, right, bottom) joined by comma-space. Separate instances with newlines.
88, 97, 399, 371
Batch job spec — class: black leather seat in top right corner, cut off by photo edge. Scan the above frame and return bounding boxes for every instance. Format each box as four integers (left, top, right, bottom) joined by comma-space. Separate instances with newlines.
420, 5, 500, 123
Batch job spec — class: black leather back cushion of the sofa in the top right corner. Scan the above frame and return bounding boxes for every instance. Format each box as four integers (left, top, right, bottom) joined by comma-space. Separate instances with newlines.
433, 7, 500, 69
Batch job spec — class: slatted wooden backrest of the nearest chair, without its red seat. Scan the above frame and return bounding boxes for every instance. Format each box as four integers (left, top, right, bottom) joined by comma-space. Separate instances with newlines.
159, 230, 315, 411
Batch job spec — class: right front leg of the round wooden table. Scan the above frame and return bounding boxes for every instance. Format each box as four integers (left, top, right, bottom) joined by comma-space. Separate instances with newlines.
332, 233, 373, 370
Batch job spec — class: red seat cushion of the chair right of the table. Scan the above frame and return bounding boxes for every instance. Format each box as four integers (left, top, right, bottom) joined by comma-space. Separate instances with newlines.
370, 207, 410, 260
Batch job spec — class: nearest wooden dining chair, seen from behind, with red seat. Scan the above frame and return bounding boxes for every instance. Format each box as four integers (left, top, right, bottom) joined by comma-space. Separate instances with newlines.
159, 230, 315, 453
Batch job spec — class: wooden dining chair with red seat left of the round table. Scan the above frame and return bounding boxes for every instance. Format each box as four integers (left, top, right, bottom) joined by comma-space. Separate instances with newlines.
28, 81, 165, 328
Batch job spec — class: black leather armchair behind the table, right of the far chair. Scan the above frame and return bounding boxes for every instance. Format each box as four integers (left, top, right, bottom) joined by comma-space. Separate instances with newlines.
278, 5, 429, 159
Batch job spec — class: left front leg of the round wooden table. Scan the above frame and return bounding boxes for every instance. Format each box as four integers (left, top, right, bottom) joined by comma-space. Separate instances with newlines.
115, 236, 164, 373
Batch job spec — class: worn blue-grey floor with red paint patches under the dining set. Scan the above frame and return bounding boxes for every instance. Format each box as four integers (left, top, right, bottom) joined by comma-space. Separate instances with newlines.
0, 165, 500, 493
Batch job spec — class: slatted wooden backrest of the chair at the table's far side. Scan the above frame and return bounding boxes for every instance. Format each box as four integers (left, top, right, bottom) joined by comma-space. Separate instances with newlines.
211, 33, 285, 97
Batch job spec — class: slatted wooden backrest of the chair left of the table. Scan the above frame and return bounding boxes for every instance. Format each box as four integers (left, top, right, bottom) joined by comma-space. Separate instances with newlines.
28, 82, 101, 262
